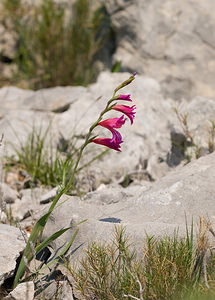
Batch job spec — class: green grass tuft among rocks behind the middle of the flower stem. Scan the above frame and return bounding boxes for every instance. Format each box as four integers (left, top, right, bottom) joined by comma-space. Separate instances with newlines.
6, 124, 108, 192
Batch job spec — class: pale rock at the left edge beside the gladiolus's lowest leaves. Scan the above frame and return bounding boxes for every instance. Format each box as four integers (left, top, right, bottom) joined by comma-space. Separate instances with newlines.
0, 224, 25, 285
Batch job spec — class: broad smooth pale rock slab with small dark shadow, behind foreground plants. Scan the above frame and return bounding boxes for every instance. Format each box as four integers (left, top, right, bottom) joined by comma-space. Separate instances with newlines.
39, 153, 215, 255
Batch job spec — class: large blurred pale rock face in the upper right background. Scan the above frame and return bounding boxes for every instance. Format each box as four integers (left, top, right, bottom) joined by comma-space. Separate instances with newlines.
105, 0, 215, 99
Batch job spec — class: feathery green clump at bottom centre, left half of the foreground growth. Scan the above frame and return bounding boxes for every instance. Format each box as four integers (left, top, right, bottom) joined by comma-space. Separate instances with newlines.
66, 227, 138, 300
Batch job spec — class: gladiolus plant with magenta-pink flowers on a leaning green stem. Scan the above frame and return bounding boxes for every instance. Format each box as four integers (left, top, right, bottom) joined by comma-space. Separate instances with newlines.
13, 73, 136, 288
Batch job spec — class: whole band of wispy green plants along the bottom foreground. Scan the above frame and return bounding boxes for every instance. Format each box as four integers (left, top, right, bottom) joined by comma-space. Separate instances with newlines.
65, 219, 215, 300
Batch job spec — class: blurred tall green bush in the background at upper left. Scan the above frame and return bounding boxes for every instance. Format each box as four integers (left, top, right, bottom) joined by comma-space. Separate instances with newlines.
3, 0, 110, 89
